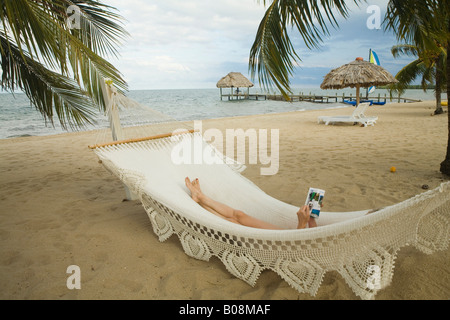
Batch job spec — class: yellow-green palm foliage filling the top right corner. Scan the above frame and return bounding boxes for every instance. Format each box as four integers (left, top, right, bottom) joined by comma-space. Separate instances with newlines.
384, 0, 450, 97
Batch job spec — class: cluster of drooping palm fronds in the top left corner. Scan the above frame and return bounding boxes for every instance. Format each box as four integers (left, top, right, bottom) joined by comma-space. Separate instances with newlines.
0, 0, 127, 128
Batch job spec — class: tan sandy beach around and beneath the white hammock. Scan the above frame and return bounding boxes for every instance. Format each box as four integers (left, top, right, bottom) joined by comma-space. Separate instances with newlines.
0, 102, 450, 300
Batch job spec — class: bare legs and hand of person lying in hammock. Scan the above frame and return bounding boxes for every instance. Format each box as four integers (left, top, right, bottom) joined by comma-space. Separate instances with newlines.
185, 177, 317, 230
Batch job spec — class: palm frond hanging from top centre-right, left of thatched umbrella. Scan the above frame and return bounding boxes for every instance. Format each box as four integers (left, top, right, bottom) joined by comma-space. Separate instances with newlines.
249, 0, 359, 98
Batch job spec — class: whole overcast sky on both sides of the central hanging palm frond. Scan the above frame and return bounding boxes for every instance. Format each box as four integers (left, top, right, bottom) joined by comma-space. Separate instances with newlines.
105, 0, 410, 90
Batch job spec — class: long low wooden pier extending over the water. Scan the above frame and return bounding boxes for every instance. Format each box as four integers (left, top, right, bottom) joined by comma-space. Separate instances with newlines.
220, 93, 422, 103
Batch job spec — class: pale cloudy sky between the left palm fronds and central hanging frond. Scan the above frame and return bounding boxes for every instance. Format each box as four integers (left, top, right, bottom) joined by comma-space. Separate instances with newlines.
108, 0, 264, 89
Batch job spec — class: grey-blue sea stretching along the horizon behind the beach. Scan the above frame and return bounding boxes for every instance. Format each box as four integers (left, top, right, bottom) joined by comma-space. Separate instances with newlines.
0, 88, 434, 139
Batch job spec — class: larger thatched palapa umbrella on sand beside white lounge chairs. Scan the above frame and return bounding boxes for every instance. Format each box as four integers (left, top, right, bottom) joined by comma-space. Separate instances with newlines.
320, 58, 398, 105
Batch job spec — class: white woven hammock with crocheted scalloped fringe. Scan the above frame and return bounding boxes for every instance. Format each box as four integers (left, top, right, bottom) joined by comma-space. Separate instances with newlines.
95, 133, 450, 299
